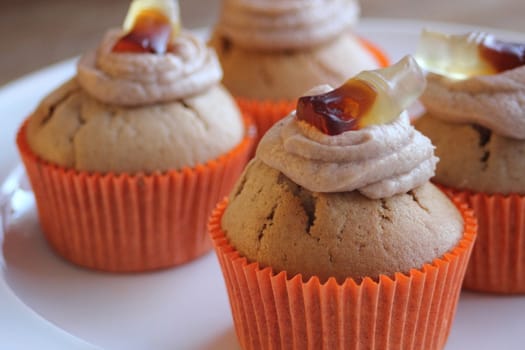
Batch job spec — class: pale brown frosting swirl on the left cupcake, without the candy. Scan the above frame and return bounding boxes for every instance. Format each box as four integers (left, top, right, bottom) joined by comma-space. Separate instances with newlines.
77, 30, 222, 106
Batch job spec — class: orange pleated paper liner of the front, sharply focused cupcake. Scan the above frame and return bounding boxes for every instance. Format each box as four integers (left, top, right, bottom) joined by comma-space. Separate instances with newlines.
209, 198, 476, 350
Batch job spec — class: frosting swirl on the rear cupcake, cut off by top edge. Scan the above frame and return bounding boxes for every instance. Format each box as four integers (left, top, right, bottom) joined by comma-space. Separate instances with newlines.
217, 0, 359, 50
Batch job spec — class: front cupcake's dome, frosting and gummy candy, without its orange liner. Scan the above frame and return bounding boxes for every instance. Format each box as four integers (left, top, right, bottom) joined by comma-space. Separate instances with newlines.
221, 57, 463, 283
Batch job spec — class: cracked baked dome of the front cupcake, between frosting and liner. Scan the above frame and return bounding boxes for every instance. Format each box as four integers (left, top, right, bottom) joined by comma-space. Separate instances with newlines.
221, 159, 463, 283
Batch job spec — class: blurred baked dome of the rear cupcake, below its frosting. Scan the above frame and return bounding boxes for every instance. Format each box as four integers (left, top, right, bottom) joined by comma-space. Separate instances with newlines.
210, 31, 386, 101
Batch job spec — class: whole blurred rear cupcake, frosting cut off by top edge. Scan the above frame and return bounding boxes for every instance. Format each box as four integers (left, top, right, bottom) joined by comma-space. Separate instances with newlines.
211, 0, 387, 148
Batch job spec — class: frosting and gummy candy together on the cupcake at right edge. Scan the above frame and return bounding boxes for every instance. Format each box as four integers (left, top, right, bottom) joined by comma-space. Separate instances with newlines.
418, 31, 525, 140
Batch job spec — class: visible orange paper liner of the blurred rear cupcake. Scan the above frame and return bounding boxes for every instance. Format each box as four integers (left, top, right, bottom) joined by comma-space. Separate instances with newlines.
236, 38, 390, 155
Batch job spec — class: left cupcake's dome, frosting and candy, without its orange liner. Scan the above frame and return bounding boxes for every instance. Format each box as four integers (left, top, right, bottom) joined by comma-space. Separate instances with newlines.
27, 0, 244, 173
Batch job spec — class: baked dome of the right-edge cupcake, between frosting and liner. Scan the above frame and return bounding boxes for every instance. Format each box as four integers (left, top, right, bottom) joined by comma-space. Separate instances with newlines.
415, 114, 525, 195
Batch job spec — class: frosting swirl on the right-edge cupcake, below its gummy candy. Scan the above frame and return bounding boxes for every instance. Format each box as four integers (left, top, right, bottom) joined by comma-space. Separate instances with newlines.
421, 66, 525, 140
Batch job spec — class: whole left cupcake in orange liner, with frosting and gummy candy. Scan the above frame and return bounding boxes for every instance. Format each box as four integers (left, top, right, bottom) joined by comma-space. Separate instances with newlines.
17, 0, 252, 272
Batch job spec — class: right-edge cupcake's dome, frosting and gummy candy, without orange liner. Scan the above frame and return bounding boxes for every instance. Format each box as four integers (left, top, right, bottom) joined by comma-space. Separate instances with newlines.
415, 31, 525, 194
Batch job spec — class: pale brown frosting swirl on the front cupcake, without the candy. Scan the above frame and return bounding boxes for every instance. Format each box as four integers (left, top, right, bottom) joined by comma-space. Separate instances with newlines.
256, 112, 438, 199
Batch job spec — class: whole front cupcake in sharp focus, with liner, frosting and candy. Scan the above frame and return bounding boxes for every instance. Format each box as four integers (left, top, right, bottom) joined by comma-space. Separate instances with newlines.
210, 57, 476, 349
